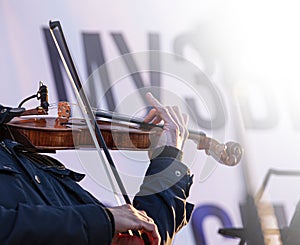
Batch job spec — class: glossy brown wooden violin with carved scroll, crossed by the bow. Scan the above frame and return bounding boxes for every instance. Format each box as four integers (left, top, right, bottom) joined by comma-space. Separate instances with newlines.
3, 102, 243, 166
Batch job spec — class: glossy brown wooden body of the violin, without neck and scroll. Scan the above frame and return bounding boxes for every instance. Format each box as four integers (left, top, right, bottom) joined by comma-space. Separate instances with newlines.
4, 116, 157, 152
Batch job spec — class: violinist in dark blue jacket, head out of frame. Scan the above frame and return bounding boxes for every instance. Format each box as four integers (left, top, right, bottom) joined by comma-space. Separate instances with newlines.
0, 94, 193, 245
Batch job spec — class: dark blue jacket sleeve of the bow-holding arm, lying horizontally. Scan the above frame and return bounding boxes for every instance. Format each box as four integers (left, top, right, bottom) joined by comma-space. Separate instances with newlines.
0, 203, 112, 245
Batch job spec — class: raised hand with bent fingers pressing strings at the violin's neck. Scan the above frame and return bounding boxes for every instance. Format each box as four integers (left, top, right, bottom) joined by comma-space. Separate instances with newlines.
144, 93, 189, 150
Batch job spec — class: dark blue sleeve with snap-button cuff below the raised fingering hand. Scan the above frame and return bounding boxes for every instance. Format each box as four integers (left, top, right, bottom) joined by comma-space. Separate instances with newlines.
133, 157, 193, 244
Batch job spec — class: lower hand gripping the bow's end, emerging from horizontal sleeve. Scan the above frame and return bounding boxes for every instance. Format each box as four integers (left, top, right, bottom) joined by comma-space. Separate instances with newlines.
109, 204, 160, 245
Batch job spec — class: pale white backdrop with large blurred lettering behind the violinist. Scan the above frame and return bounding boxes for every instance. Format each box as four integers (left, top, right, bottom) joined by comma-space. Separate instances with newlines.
0, 0, 300, 244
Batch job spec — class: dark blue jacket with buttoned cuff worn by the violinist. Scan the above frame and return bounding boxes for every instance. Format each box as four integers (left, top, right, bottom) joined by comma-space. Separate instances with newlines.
0, 140, 193, 245
